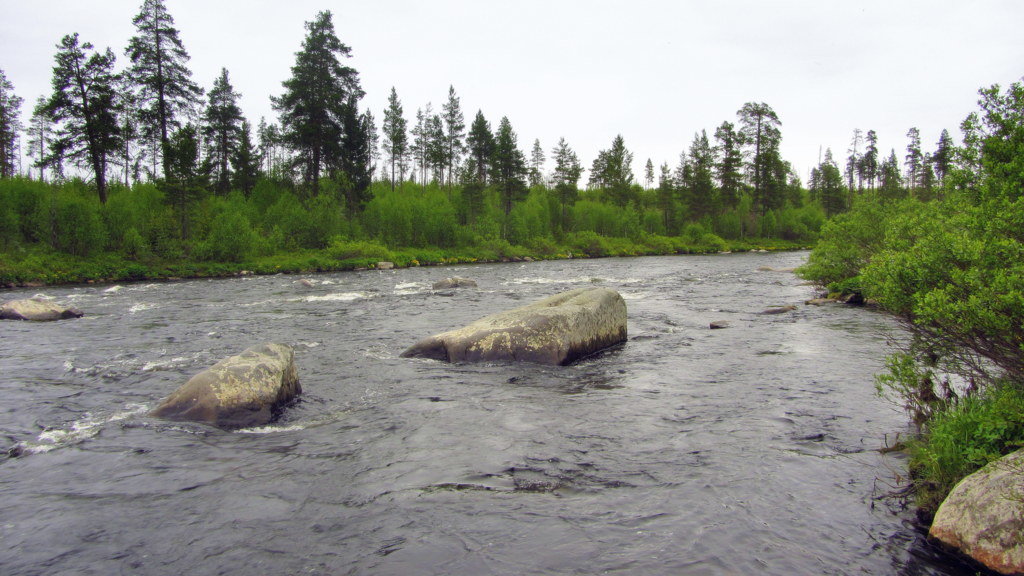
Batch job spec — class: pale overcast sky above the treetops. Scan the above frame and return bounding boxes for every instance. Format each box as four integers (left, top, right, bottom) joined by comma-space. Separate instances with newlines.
0, 0, 1024, 183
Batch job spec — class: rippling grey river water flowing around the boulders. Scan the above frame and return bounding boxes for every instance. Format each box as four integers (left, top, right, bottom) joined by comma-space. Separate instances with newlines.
0, 253, 973, 575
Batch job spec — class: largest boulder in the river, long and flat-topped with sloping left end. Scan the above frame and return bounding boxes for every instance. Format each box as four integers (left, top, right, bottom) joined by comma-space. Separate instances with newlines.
401, 288, 626, 365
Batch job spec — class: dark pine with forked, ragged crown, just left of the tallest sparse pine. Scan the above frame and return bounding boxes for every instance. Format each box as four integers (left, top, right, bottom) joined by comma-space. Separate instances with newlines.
45, 34, 121, 204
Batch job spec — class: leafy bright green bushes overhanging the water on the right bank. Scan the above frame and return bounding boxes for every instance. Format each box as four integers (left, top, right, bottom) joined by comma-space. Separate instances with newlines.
801, 77, 1024, 511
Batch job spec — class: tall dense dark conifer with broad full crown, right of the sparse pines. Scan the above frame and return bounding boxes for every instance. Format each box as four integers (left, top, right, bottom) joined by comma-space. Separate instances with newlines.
270, 11, 362, 196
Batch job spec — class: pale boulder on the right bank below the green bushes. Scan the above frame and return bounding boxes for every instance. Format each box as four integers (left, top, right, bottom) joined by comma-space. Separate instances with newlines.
929, 450, 1024, 575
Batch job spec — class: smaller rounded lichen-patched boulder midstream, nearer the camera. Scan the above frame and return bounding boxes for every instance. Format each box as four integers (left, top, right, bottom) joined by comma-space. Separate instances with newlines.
153, 343, 302, 428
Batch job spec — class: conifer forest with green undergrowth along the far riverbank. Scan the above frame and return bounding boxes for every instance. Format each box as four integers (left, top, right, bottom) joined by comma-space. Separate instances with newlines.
0, 0, 880, 285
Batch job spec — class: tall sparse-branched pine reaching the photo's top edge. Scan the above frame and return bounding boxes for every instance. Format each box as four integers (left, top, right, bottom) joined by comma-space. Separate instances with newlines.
125, 0, 203, 177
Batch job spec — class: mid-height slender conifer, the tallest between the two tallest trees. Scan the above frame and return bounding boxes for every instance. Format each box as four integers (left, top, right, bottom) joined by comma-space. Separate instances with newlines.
203, 68, 244, 194
